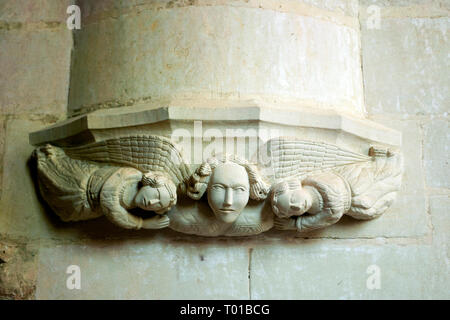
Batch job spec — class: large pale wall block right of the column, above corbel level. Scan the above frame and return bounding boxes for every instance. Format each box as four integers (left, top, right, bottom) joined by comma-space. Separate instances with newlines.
361, 15, 450, 114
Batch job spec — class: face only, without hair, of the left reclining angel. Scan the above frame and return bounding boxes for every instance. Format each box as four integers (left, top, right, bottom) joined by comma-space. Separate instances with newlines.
134, 186, 176, 214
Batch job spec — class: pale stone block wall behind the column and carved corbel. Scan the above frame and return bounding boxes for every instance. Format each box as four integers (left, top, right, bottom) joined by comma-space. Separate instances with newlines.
0, 0, 450, 299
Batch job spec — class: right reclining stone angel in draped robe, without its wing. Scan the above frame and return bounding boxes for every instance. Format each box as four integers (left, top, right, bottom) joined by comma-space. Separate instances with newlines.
270, 148, 403, 232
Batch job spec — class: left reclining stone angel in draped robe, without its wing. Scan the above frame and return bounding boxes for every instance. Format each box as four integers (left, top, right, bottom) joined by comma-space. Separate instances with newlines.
34, 145, 177, 229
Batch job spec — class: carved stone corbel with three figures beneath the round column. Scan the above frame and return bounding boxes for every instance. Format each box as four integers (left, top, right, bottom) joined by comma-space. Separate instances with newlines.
30, 107, 403, 236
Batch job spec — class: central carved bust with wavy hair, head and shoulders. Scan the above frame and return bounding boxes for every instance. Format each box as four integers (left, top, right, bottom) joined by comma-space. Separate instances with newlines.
170, 156, 273, 236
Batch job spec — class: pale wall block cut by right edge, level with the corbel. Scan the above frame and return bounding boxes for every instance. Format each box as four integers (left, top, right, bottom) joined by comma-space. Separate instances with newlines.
423, 117, 450, 188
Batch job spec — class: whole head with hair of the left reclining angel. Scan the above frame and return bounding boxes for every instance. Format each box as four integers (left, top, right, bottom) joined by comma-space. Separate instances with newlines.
134, 172, 177, 214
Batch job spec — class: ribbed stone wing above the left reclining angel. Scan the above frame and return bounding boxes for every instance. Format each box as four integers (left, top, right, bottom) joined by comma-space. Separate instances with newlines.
64, 135, 191, 191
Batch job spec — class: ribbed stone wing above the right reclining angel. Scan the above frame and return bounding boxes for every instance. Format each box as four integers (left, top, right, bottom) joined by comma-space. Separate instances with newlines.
257, 137, 371, 183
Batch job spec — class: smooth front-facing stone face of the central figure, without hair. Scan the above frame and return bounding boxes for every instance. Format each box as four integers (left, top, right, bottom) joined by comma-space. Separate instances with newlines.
208, 163, 250, 223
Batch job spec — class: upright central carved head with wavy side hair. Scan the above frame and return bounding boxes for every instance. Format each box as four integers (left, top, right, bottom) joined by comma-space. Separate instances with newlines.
188, 156, 269, 223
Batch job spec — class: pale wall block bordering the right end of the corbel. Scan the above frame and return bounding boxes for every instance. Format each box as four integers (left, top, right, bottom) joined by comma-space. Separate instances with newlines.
282, 117, 431, 238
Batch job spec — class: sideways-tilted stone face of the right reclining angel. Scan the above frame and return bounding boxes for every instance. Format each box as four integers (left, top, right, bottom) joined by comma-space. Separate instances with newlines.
271, 181, 313, 218
